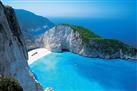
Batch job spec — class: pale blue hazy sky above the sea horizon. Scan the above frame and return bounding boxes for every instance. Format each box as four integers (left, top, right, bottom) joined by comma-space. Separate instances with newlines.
2, 0, 137, 18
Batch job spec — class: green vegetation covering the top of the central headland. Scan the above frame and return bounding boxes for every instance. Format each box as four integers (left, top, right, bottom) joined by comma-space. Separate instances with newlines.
63, 24, 137, 55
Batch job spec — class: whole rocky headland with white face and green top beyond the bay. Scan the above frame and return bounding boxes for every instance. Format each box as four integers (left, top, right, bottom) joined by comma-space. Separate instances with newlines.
43, 24, 137, 59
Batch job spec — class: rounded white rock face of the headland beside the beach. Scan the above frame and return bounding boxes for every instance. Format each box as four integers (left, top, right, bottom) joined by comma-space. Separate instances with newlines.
43, 25, 84, 54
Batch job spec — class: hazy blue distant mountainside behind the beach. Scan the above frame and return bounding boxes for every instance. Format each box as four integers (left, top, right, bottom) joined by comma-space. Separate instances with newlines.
15, 9, 54, 50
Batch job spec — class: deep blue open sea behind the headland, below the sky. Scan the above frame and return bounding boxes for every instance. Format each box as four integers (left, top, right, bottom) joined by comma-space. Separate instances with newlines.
49, 16, 137, 47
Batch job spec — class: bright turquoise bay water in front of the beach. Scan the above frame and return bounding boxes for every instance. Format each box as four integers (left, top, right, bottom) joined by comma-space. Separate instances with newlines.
30, 52, 137, 91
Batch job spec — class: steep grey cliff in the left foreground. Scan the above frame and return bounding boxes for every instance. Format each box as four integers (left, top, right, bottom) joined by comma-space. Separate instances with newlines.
0, 2, 43, 91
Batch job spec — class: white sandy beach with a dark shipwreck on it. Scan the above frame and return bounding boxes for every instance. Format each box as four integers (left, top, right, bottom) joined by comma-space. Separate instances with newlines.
28, 48, 51, 65
